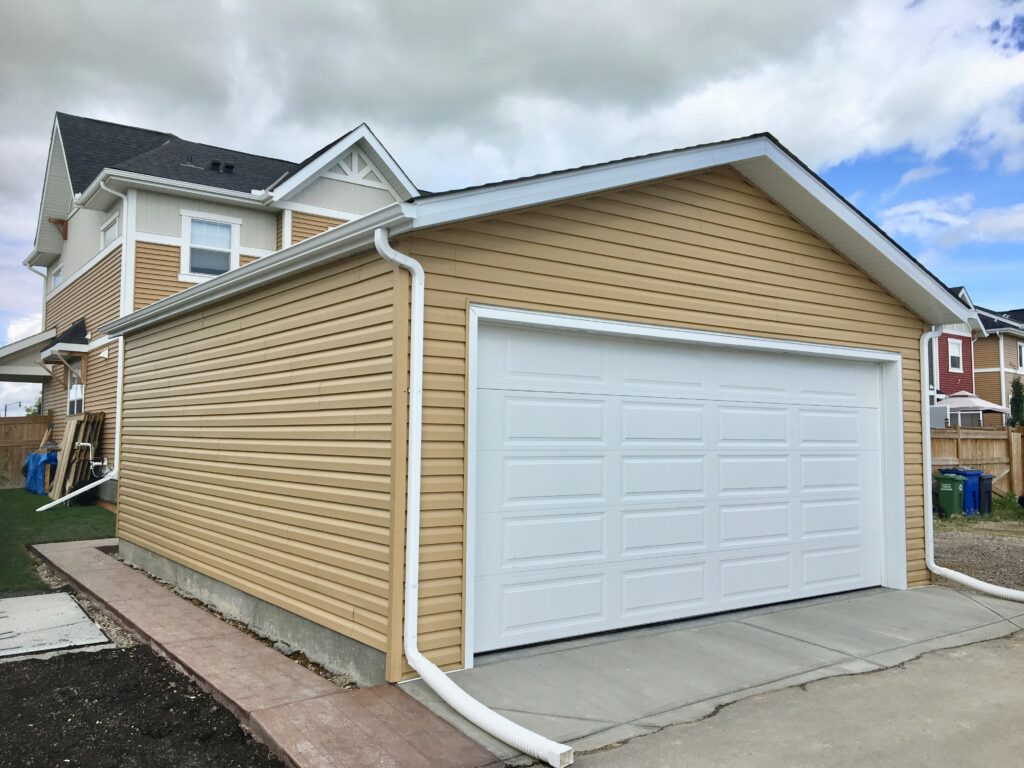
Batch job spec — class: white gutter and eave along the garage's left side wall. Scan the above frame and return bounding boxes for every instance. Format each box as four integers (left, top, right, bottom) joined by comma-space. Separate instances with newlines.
100, 203, 416, 336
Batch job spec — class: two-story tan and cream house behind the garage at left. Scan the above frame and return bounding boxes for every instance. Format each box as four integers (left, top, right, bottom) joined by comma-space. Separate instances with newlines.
0, 113, 415, 496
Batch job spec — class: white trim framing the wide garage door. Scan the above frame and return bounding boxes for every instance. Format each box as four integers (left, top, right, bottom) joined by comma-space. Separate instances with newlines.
463, 304, 907, 669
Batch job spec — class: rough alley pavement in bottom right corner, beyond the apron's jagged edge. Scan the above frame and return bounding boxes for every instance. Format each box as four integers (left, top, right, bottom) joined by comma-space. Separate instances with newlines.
575, 635, 1024, 768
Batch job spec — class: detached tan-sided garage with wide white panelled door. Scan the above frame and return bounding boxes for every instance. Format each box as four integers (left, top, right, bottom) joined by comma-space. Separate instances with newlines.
110, 135, 972, 692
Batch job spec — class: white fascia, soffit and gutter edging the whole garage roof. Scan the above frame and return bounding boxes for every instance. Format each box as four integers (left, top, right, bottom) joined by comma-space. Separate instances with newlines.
104, 133, 976, 334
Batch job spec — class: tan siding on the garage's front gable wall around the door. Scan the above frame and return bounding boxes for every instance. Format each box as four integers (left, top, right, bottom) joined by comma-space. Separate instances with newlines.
392, 170, 930, 674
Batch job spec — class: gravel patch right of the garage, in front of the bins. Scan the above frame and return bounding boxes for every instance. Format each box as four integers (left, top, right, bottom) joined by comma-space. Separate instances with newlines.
935, 522, 1024, 589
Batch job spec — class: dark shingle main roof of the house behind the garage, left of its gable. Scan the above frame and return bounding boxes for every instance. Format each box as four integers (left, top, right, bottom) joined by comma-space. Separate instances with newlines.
57, 112, 296, 195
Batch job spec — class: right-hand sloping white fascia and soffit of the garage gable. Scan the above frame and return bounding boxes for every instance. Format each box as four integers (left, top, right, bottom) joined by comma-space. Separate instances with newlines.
736, 147, 976, 326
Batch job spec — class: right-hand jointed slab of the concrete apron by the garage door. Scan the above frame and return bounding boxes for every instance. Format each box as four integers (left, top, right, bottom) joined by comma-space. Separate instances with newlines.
744, 587, 998, 657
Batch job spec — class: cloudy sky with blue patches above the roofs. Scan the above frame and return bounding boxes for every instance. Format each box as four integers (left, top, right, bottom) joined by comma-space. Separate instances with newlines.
0, 0, 1024, 415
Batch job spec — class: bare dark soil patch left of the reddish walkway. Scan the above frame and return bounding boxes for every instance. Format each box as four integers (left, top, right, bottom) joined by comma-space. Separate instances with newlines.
0, 646, 283, 768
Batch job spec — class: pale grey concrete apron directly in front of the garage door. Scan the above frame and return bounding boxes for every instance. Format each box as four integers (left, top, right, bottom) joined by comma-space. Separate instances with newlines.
401, 587, 1024, 765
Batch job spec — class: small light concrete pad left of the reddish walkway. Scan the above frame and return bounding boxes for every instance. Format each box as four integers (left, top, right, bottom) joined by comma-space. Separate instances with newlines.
0, 592, 110, 657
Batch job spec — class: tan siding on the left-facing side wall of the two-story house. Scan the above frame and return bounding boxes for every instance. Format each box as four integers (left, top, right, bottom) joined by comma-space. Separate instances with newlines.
43, 248, 121, 457
